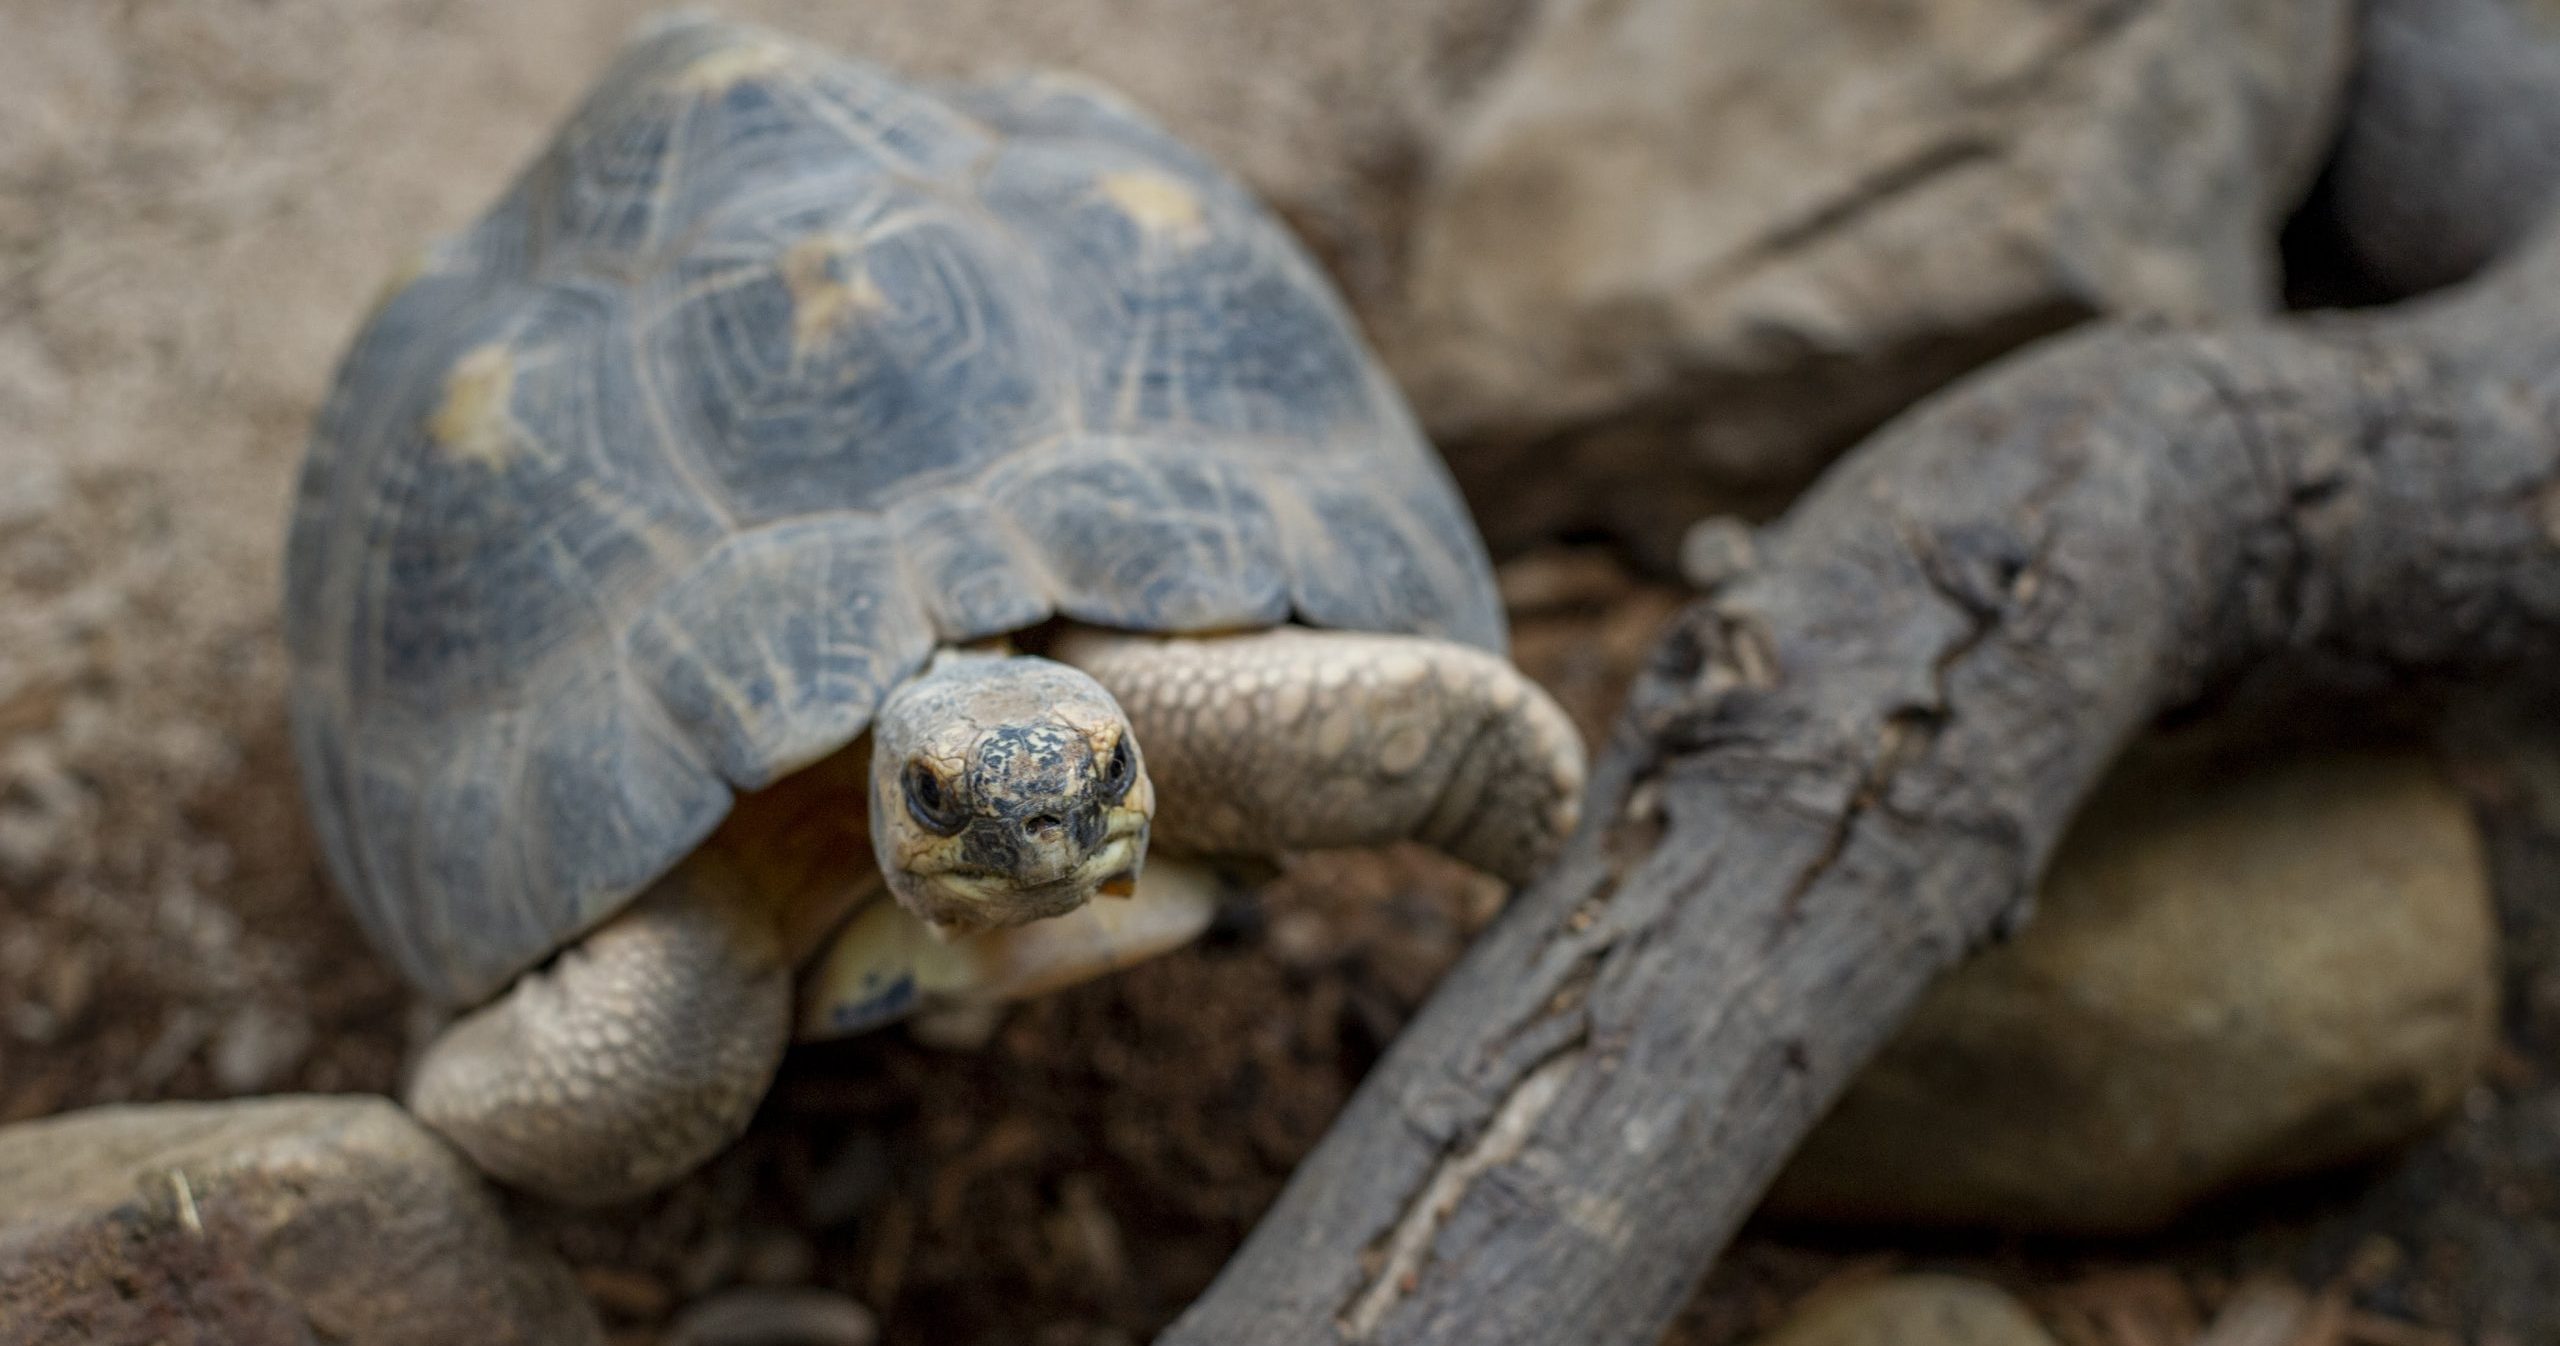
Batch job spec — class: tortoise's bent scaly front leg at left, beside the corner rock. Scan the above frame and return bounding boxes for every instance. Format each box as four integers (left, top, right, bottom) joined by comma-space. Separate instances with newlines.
407, 855, 791, 1205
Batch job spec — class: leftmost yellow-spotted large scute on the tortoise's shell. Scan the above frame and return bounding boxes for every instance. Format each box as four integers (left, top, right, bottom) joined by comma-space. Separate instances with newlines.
350, 284, 722, 714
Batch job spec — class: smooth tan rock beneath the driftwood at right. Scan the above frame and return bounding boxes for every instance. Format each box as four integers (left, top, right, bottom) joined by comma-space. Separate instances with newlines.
1769, 752, 2499, 1233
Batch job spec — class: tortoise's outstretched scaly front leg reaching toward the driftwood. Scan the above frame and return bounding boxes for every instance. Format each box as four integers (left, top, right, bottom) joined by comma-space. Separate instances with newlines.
1055, 627, 1582, 885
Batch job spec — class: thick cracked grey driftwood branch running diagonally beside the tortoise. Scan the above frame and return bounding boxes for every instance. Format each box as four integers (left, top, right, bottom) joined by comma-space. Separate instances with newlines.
1162, 2, 2560, 1346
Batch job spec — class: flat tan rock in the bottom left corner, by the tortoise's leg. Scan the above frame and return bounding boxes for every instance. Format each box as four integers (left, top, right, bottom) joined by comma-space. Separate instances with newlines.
0, 1098, 602, 1346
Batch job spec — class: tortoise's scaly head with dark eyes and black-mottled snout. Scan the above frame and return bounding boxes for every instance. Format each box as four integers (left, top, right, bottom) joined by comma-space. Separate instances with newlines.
870, 650, 1155, 934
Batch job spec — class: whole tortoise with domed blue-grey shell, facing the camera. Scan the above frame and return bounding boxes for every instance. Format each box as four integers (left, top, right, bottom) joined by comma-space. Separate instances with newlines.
284, 15, 1582, 1203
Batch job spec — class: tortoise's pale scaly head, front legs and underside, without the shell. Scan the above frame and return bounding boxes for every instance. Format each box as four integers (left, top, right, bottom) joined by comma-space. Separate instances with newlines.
410, 627, 1582, 1203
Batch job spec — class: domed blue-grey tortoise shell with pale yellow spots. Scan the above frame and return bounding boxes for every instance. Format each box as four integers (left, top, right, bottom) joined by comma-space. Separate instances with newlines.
284, 20, 1503, 1001
